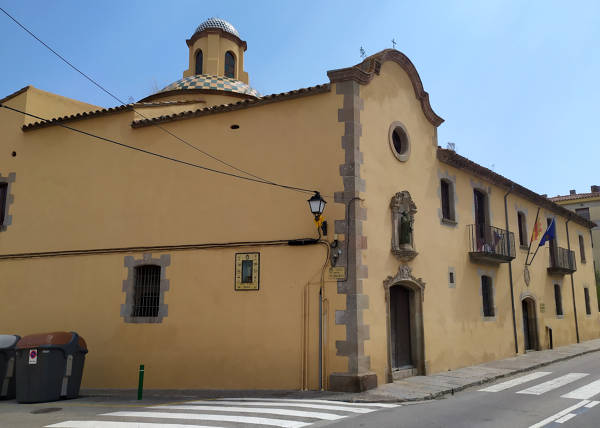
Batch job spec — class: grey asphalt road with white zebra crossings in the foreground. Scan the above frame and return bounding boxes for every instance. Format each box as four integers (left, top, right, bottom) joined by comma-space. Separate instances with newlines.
0, 353, 600, 428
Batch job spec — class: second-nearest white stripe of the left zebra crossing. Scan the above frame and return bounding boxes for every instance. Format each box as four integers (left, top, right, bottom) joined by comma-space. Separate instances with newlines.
101, 412, 311, 428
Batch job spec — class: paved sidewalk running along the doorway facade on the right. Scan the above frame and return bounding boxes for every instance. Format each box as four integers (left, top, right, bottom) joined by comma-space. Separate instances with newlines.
352, 339, 600, 402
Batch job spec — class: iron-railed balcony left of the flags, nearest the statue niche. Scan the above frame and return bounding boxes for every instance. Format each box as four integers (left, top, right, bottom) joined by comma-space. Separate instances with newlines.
467, 224, 516, 263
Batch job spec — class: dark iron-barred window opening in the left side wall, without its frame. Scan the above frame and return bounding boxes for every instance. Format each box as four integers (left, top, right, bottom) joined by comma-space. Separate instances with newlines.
131, 265, 161, 317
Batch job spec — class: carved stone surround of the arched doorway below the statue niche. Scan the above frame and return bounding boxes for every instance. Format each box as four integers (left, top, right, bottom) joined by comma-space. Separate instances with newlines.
383, 265, 427, 382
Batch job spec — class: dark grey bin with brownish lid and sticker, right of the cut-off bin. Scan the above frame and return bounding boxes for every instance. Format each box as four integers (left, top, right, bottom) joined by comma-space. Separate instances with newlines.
16, 331, 87, 403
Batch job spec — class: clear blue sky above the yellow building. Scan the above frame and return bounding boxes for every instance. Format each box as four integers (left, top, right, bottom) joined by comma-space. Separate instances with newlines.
0, 0, 600, 196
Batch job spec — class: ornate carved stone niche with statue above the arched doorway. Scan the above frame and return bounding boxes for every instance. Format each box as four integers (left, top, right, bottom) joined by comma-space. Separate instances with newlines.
390, 190, 417, 261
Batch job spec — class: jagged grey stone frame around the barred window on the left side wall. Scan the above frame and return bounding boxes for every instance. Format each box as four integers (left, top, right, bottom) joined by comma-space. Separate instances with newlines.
121, 253, 171, 324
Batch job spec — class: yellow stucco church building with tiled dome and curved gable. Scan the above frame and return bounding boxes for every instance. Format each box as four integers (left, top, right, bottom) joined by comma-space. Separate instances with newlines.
0, 19, 600, 391
